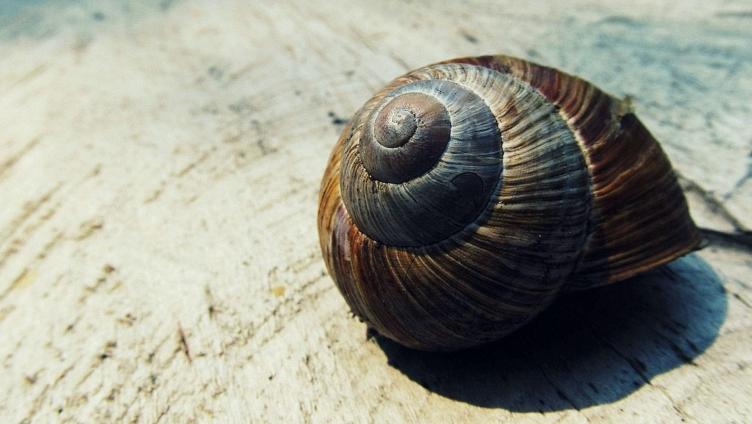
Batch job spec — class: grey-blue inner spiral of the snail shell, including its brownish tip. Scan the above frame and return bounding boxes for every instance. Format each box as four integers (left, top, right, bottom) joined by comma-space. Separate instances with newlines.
341, 80, 502, 247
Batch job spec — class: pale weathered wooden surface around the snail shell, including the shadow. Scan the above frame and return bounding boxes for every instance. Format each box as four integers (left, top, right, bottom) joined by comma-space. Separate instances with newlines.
0, 0, 752, 423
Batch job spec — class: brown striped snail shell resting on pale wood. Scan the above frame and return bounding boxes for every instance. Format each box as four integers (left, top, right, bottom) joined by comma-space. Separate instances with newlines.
318, 56, 700, 350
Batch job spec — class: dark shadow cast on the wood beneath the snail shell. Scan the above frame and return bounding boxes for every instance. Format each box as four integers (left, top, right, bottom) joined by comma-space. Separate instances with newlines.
376, 255, 727, 412
